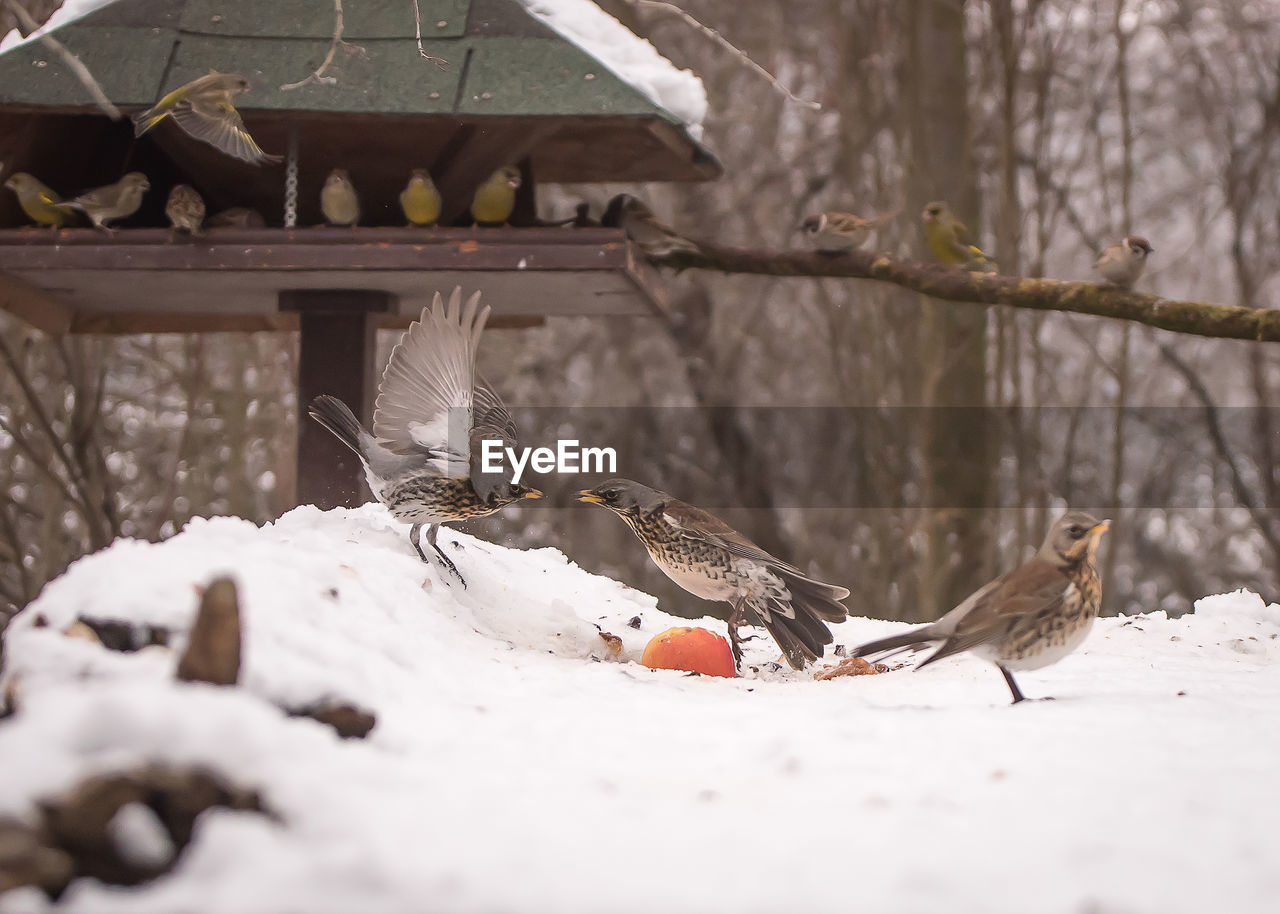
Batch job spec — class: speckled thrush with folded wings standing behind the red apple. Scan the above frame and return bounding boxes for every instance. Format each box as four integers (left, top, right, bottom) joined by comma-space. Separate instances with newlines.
577, 479, 849, 669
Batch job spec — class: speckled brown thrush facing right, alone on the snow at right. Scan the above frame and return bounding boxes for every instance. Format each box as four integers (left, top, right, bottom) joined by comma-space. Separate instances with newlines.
852, 511, 1111, 704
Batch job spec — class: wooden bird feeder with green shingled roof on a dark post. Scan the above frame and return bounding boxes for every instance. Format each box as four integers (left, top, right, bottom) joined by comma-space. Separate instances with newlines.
0, 0, 721, 507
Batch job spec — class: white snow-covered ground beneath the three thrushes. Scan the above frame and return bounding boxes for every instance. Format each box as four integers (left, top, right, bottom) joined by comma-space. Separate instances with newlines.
0, 506, 1280, 914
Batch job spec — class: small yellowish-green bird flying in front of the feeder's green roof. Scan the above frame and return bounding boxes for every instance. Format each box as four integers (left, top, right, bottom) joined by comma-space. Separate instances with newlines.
133, 70, 280, 165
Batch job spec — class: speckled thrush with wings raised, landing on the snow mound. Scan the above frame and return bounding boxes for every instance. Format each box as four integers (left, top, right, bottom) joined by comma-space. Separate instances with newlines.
310, 288, 543, 586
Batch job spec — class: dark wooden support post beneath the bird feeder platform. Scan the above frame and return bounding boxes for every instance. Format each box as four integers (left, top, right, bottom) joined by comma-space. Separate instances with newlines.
279, 289, 393, 508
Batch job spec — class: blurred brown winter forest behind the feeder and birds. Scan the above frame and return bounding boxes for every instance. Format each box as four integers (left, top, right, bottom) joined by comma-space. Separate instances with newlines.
0, 0, 1280, 634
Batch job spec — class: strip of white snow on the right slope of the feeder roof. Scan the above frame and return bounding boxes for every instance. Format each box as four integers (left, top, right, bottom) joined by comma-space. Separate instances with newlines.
518, 0, 707, 131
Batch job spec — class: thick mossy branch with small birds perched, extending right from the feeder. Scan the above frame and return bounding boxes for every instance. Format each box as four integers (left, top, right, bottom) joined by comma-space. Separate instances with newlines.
650, 242, 1280, 343
